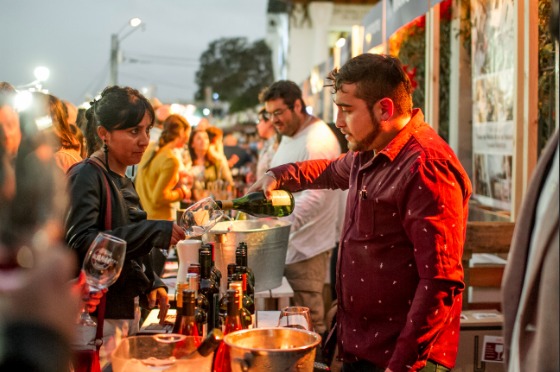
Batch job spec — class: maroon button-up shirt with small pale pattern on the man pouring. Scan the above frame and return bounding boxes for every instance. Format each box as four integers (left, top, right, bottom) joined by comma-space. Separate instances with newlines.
272, 110, 471, 372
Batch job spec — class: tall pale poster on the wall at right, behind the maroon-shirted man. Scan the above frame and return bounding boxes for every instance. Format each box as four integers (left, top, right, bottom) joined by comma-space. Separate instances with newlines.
471, 0, 515, 211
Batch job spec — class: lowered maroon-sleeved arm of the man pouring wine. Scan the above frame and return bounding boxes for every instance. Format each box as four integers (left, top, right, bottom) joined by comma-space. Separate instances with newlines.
389, 160, 470, 371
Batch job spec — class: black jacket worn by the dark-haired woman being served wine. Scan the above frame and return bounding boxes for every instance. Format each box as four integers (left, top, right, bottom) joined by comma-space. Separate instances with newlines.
66, 159, 173, 319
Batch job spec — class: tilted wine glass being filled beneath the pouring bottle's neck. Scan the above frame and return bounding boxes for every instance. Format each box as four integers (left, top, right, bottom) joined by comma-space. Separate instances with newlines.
179, 197, 224, 238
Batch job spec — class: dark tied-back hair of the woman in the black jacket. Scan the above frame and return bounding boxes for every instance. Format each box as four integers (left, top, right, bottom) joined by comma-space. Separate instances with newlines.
86, 85, 155, 155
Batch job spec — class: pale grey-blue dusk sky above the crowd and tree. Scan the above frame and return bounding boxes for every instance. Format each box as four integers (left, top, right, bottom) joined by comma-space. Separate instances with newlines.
0, 0, 268, 104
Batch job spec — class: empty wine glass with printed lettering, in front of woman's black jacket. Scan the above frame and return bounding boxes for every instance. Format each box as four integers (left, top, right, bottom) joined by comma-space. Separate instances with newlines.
78, 232, 126, 327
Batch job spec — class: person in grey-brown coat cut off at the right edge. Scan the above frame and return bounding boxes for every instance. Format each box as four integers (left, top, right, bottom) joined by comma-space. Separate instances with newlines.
502, 0, 560, 372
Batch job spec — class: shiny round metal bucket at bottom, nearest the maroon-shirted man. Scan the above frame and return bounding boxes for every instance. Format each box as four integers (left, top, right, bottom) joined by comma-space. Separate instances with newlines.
224, 328, 321, 372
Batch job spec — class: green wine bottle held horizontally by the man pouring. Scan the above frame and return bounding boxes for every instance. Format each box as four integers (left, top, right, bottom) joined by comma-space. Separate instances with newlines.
216, 190, 294, 217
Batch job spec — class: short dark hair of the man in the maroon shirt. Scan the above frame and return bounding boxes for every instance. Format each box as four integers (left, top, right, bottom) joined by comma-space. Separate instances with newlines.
325, 53, 412, 114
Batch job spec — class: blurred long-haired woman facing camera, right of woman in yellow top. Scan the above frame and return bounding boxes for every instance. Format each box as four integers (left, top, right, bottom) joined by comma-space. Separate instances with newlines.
188, 127, 233, 200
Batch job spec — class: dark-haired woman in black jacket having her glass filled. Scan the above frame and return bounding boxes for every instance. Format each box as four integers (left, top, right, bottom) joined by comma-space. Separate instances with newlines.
66, 86, 185, 362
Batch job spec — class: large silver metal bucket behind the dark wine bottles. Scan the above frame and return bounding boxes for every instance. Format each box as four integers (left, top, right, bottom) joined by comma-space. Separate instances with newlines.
208, 218, 291, 293
